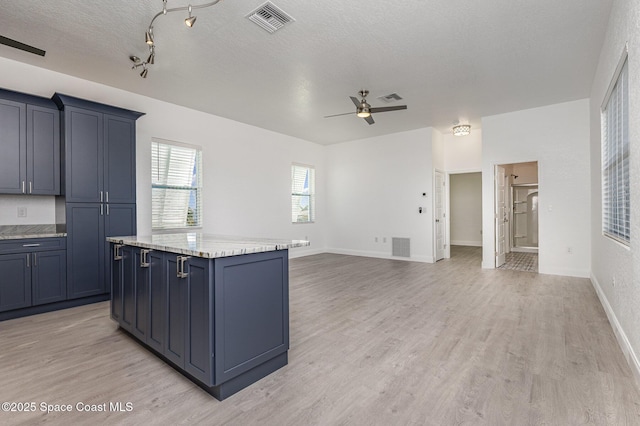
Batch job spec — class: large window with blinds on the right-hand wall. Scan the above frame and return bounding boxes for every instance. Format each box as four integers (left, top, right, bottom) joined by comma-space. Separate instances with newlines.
602, 58, 631, 245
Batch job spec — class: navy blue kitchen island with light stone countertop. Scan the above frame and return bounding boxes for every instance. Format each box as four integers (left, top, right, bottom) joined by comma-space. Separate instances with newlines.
107, 233, 309, 400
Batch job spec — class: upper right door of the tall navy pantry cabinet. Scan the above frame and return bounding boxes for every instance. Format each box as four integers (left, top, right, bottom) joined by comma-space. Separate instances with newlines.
104, 114, 136, 203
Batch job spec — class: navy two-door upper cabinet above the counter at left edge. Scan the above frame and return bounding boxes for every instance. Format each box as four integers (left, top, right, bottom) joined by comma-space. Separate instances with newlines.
0, 89, 60, 195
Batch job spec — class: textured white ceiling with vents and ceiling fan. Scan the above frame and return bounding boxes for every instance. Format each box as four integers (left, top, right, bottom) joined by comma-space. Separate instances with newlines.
0, 0, 612, 144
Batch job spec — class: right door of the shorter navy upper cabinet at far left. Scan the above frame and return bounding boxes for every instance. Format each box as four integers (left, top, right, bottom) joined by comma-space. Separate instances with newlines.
26, 105, 60, 195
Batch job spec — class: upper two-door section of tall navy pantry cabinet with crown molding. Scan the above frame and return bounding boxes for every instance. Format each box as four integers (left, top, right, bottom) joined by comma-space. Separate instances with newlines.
53, 93, 143, 204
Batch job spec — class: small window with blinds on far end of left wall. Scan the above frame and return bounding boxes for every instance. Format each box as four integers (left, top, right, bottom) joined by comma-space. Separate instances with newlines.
291, 164, 316, 223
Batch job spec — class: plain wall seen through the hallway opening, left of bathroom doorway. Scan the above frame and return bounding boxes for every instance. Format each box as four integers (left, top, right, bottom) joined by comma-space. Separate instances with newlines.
449, 172, 482, 247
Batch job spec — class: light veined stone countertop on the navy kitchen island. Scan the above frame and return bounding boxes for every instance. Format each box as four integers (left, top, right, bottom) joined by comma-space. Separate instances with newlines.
107, 233, 311, 259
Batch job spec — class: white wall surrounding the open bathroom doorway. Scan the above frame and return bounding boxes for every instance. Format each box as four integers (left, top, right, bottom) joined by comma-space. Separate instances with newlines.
482, 99, 591, 277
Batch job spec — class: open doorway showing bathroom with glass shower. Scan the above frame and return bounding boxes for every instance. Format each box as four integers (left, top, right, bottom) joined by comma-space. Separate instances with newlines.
495, 161, 539, 272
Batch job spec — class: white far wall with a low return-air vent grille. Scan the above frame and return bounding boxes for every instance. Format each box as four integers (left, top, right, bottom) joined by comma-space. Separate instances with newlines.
326, 128, 441, 262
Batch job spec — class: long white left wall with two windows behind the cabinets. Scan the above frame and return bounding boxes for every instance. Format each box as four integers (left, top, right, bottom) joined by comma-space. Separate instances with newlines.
0, 58, 326, 255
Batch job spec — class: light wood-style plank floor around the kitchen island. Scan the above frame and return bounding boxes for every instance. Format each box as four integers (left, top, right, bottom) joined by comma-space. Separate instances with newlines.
0, 248, 640, 426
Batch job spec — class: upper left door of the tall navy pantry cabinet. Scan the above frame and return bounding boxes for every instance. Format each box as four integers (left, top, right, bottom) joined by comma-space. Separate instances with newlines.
64, 107, 104, 203
